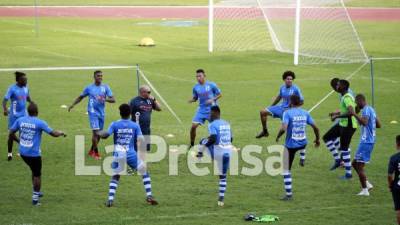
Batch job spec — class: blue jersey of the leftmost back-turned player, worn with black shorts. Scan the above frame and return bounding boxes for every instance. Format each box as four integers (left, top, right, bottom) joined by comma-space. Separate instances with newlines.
10, 116, 53, 157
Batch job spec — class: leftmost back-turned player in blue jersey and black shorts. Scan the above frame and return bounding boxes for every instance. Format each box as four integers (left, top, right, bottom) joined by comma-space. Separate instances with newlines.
9, 103, 66, 206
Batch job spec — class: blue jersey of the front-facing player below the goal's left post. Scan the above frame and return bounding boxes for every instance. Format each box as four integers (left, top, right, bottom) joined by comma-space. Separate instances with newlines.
193, 81, 221, 113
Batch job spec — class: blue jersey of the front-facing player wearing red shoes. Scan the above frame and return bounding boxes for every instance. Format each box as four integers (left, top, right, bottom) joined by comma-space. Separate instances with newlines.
81, 84, 113, 117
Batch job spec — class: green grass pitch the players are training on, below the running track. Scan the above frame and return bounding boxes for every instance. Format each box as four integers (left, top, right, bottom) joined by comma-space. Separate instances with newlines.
0, 11, 400, 225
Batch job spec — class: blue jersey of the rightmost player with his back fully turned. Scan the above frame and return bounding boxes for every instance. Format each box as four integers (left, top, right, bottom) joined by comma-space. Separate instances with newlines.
282, 108, 314, 148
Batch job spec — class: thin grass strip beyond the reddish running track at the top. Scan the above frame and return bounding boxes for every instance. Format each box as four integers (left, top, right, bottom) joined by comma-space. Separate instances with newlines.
0, 0, 400, 7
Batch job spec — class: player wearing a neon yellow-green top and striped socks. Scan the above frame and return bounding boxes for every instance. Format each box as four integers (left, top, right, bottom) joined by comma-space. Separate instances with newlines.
329, 80, 357, 180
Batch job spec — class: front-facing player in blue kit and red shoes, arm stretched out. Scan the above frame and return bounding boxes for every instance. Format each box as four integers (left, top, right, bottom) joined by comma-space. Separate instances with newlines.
68, 70, 115, 159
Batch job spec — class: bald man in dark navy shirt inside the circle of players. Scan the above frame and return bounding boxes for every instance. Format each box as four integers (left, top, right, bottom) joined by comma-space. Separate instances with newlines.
129, 85, 161, 151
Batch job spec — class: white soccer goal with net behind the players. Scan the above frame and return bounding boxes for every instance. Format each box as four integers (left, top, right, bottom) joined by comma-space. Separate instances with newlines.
209, 0, 368, 65
